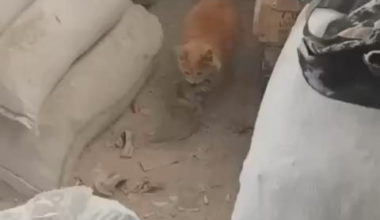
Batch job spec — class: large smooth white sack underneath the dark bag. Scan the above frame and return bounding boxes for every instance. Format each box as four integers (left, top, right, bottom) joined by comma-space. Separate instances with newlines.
232, 8, 380, 220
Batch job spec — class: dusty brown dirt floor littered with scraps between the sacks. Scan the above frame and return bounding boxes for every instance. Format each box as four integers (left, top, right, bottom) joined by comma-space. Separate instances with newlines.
75, 0, 262, 220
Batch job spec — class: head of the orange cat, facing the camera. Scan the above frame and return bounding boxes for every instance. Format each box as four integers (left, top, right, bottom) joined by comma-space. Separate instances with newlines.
175, 42, 221, 84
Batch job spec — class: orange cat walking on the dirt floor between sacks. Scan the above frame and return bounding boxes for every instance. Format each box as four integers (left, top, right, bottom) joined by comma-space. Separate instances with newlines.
176, 0, 240, 84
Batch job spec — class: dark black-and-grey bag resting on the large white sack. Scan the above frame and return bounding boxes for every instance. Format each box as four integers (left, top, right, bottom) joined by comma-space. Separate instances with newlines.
298, 0, 380, 109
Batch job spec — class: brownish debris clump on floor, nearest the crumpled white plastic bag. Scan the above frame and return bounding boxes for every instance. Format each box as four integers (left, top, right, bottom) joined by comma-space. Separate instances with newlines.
93, 168, 127, 198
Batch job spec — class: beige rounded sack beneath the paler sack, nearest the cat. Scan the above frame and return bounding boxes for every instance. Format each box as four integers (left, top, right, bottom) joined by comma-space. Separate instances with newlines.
0, 0, 163, 193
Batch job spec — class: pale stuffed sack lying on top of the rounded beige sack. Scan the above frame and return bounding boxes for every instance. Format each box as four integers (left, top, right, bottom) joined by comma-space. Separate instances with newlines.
0, 0, 131, 129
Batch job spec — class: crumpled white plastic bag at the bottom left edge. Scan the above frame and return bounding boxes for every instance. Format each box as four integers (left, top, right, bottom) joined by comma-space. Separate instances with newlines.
0, 186, 139, 220
